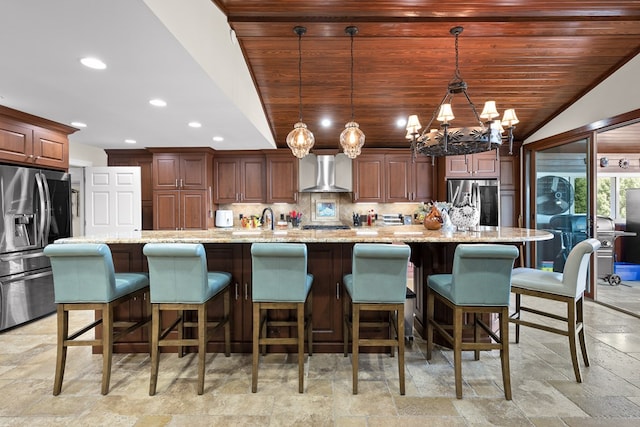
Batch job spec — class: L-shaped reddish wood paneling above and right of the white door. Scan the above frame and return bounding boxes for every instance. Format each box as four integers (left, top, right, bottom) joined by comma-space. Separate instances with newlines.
105, 150, 153, 230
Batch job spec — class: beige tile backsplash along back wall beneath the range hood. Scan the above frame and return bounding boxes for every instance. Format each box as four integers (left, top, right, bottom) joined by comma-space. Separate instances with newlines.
218, 193, 420, 227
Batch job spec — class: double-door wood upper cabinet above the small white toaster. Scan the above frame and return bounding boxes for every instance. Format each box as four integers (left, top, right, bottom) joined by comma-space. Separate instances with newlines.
213, 152, 266, 203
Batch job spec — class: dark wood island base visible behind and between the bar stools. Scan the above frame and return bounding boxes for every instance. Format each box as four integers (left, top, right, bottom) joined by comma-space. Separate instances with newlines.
102, 243, 491, 353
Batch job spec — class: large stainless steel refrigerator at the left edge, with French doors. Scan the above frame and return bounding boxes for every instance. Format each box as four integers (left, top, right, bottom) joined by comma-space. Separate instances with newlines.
0, 165, 71, 330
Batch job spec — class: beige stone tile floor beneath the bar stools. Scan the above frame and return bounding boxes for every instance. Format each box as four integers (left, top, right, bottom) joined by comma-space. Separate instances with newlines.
0, 296, 640, 427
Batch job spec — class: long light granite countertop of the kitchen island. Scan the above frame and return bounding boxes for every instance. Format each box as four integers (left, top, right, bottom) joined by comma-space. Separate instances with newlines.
56, 225, 553, 244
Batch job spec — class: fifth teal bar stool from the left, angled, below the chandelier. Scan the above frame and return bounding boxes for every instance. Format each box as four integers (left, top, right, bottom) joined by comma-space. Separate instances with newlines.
427, 244, 519, 400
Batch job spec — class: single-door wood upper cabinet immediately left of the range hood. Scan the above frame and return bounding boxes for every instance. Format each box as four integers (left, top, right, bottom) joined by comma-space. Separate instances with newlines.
265, 150, 299, 203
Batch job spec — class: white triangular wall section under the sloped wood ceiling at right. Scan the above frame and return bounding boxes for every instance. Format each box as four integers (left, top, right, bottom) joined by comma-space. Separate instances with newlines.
524, 55, 640, 144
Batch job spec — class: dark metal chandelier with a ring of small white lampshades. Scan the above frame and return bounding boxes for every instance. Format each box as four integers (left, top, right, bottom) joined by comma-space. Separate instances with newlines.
406, 27, 518, 157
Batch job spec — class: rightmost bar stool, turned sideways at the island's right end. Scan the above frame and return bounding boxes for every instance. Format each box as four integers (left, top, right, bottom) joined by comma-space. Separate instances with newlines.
509, 239, 600, 383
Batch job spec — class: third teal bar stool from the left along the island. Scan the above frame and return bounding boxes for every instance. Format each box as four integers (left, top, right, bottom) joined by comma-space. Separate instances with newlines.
251, 243, 313, 393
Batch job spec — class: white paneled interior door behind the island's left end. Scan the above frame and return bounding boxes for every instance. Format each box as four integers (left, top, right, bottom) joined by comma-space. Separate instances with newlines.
84, 166, 142, 236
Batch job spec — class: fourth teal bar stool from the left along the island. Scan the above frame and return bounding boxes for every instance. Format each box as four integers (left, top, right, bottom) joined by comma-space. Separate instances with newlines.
343, 243, 411, 395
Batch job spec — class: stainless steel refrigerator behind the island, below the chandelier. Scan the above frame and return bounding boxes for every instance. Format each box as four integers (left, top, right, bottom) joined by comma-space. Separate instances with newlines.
447, 179, 500, 227
